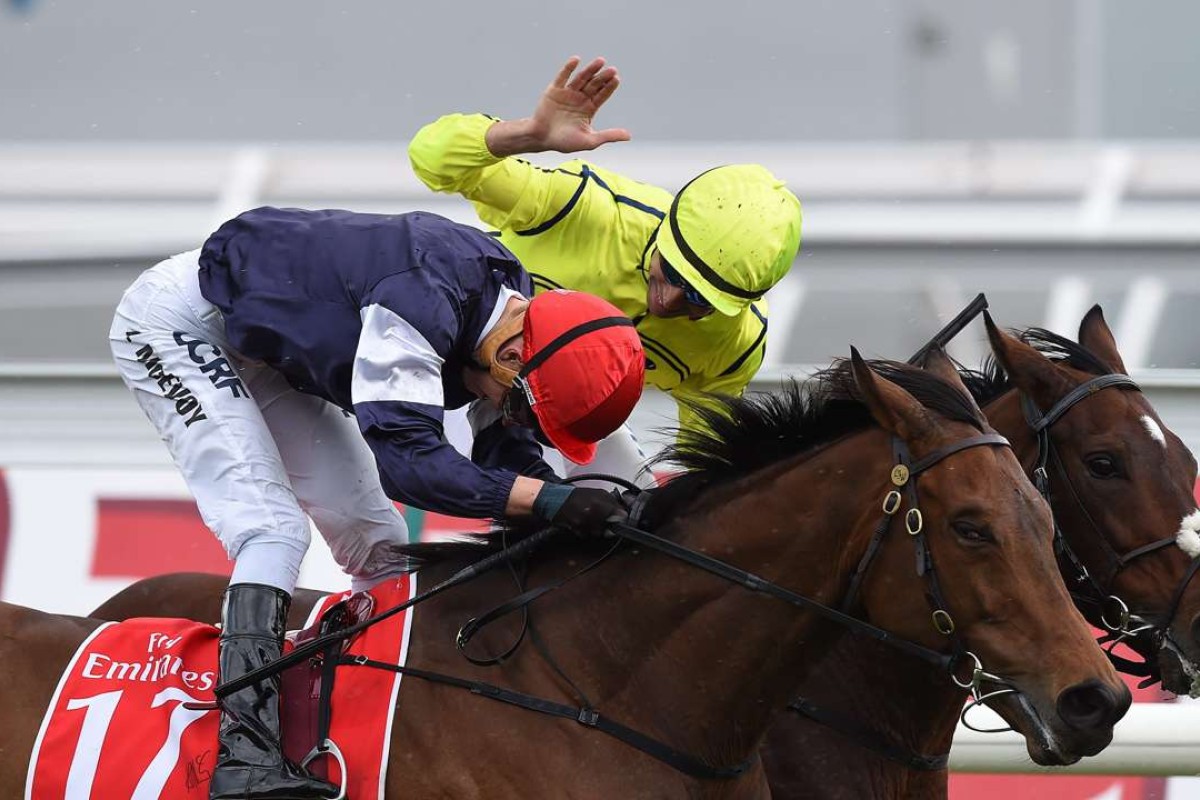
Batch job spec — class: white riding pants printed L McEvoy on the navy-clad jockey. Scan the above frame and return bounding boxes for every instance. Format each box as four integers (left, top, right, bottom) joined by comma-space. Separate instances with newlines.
109, 249, 408, 594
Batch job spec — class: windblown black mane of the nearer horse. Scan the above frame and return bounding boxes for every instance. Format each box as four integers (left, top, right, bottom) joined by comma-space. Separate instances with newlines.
396, 360, 984, 570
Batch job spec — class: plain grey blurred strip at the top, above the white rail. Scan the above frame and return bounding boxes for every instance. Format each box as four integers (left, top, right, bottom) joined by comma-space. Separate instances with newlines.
7, 0, 1200, 143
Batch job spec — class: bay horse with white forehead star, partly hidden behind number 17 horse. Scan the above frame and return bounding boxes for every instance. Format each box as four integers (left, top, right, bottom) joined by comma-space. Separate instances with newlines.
763, 306, 1200, 800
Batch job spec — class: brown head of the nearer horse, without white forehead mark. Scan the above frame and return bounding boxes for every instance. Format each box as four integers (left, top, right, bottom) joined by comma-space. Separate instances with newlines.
852, 354, 1130, 764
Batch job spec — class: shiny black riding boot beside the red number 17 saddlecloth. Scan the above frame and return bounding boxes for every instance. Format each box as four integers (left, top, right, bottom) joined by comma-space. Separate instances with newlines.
209, 583, 337, 800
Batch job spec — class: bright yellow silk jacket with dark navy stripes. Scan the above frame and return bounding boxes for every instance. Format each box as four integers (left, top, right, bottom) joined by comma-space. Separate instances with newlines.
408, 114, 767, 428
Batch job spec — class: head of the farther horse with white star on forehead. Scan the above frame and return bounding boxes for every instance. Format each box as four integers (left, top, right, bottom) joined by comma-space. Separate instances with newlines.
986, 306, 1200, 693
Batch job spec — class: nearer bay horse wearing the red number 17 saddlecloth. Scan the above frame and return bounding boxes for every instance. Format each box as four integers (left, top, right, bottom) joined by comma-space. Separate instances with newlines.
60, 354, 1130, 798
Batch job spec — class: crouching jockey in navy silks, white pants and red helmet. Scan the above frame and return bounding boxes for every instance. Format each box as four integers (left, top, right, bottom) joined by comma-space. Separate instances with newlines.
109, 207, 646, 799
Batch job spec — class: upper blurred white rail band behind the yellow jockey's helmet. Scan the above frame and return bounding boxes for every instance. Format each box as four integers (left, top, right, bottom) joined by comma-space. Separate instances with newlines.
0, 142, 1200, 261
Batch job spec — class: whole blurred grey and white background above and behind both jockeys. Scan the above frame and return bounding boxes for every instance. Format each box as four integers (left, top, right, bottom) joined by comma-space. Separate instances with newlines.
0, 0, 1200, 463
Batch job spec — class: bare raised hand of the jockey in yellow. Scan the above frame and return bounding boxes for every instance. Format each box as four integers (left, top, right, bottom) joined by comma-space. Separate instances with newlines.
487, 56, 630, 156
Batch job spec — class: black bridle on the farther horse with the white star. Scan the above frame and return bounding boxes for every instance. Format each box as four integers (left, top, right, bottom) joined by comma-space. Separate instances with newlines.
1021, 373, 1200, 686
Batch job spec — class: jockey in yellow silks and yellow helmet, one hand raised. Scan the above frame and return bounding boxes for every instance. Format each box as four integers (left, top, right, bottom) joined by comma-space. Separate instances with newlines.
408, 58, 802, 477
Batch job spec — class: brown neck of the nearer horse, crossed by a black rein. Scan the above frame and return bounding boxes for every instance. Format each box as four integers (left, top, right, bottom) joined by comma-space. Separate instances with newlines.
566, 431, 890, 764
